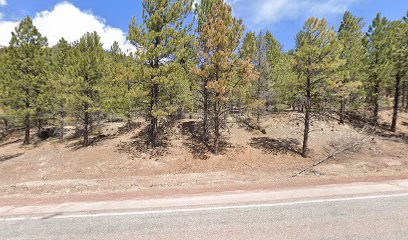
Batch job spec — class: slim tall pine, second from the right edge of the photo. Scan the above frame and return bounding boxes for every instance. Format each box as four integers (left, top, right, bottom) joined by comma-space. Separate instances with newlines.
365, 13, 390, 126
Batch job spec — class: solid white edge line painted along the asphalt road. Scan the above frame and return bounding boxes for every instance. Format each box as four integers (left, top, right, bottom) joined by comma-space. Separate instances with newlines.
0, 193, 408, 222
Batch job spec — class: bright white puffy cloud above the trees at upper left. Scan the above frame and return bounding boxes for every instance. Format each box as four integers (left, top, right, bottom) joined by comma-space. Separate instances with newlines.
0, 2, 134, 51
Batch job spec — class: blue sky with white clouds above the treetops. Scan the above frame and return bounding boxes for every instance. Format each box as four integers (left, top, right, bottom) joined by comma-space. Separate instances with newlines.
0, 0, 408, 50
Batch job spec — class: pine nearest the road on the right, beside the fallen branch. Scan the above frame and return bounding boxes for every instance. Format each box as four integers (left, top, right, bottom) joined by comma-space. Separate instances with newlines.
291, 18, 342, 157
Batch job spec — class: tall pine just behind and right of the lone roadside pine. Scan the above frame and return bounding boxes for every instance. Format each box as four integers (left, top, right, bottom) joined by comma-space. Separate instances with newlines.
336, 12, 366, 124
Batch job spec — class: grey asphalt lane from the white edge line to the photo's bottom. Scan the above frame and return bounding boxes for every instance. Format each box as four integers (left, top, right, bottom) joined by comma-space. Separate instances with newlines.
0, 183, 408, 240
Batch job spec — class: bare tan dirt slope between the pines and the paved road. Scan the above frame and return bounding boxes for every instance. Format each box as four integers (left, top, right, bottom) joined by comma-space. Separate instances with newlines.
0, 111, 408, 205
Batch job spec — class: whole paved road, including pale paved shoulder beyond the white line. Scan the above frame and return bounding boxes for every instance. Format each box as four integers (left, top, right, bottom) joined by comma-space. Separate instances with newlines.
0, 182, 408, 240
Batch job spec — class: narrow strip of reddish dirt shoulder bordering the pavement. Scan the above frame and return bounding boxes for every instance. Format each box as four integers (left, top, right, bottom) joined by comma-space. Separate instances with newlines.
0, 174, 408, 207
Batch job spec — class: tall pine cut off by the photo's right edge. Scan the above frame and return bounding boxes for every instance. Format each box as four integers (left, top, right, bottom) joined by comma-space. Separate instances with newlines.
388, 12, 408, 132
